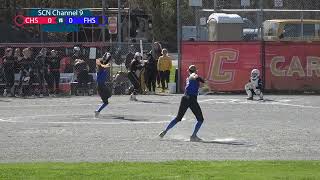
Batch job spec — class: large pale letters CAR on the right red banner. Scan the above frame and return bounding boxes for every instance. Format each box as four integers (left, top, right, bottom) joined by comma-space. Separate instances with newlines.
270, 56, 320, 77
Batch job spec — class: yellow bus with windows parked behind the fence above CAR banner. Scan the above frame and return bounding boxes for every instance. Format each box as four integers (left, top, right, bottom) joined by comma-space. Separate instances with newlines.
263, 19, 320, 41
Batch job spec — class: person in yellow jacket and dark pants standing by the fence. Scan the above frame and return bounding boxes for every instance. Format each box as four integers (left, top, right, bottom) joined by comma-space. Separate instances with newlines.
158, 49, 172, 92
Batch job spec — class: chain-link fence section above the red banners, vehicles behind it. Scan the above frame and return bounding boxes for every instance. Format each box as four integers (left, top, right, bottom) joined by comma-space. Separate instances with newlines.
178, 0, 320, 41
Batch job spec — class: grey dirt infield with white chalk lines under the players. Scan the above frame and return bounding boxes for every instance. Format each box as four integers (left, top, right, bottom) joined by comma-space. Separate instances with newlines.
0, 95, 320, 162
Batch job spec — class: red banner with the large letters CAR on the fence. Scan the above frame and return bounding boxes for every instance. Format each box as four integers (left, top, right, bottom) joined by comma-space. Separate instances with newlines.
265, 42, 320, 91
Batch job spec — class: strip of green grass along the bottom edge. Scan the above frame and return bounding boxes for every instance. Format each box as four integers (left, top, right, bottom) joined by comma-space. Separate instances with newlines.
0, 161, 320, 180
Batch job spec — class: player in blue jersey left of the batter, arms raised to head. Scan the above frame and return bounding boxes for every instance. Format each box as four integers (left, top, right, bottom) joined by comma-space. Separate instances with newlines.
95, 52, 112, 118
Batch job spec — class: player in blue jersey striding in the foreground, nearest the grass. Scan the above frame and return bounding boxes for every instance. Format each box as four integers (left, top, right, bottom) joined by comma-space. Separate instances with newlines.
159, 65, 204, 141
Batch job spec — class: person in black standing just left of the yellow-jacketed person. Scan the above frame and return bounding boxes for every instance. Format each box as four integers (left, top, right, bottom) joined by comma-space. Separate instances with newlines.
145, 52, 157, 94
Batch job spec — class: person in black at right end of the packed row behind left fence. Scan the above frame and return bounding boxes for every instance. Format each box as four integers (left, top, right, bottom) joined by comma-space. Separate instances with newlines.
48, 49, 61, 96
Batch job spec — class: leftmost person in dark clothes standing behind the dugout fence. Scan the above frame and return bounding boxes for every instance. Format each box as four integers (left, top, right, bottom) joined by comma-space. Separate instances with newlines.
2, 48, 14, 96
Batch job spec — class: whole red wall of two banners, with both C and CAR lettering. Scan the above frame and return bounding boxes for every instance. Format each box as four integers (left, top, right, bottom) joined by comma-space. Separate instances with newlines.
180, 42, 320, 91
